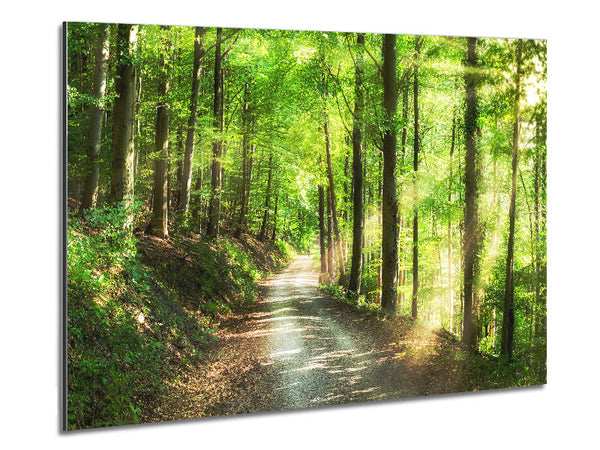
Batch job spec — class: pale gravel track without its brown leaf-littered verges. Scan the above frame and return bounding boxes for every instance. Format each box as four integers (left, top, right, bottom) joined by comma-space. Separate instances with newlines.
262, 256, 418, 409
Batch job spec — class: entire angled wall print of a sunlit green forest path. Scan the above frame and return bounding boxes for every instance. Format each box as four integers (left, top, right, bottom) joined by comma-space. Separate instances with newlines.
64, 22, 547, 430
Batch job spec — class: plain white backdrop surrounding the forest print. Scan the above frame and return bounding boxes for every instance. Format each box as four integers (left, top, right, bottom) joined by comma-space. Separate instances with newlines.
0, 0, 600, 450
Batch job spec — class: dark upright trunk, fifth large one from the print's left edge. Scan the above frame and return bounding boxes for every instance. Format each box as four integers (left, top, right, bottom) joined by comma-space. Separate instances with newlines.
206, 28, 224, 237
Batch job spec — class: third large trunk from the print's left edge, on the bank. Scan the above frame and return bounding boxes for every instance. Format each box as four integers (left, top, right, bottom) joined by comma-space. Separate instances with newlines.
152, 26, 171, 238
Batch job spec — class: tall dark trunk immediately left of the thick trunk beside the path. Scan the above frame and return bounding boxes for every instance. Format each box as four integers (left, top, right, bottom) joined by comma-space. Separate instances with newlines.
348, 33, 365, 298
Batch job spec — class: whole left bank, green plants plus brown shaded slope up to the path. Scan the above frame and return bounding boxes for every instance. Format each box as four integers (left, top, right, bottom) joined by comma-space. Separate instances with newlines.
67, 206, 285, 429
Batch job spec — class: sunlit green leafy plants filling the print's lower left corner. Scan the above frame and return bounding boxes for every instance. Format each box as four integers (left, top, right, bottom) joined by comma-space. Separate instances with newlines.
67, 207, 212, 429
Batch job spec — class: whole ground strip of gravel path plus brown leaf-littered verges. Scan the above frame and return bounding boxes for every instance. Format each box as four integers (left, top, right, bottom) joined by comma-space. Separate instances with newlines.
143, 256, 468, 422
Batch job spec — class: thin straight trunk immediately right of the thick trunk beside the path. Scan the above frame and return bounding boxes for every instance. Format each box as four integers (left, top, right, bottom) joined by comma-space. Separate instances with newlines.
411, 36, 421, 320
